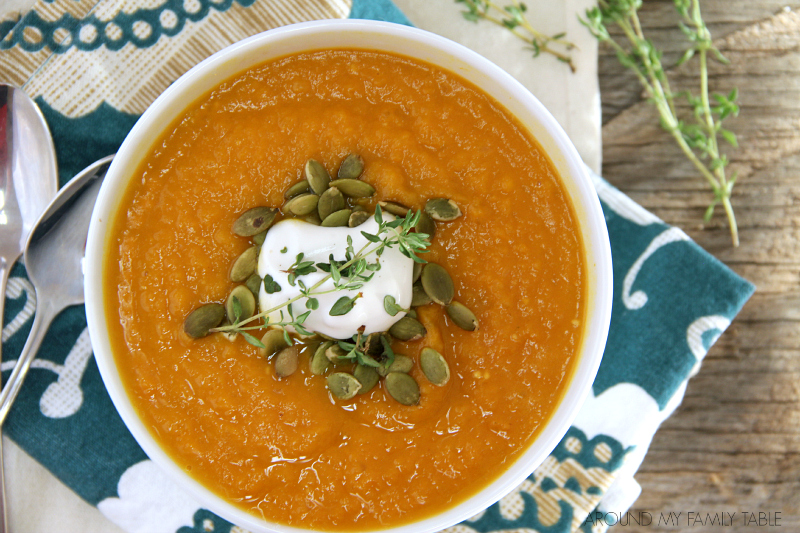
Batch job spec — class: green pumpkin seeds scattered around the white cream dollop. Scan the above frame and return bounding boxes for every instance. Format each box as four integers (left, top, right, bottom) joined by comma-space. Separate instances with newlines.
184, 154, 478, 405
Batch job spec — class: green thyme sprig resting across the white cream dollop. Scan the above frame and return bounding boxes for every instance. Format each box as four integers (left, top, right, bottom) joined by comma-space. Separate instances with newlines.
210, 205, 430, 348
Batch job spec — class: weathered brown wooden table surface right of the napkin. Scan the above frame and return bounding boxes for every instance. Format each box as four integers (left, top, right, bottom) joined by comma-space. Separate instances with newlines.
599, 0, 800, 532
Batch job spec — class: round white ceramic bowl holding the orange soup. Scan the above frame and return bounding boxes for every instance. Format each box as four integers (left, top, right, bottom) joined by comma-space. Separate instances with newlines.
85, 16, 612, 533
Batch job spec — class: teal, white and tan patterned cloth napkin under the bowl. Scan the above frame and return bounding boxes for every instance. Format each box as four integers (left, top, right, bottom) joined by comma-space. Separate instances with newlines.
0, 0, 754, 533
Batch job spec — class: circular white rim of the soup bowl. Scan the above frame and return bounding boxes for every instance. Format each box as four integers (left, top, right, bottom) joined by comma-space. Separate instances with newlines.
84, 19, 613, 533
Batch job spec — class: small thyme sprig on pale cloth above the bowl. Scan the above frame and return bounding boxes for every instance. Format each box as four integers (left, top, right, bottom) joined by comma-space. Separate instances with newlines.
455, 0, 575, 72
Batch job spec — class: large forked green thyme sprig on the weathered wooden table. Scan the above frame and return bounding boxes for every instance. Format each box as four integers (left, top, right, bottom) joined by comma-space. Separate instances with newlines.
581, 0, 739, 246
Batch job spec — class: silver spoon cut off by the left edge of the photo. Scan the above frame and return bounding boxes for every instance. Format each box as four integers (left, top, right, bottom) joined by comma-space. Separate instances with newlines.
0, 84, 58, 533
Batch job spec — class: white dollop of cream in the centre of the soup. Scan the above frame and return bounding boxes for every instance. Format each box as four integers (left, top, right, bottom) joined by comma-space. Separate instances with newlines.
258, 214, 414, 339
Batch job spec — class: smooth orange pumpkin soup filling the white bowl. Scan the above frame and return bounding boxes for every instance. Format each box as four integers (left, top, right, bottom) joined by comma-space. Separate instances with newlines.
105, 50, 585, 531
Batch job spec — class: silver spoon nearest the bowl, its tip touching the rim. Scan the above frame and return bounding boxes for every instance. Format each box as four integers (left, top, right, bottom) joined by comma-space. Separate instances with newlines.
0, 156, 113, 425
